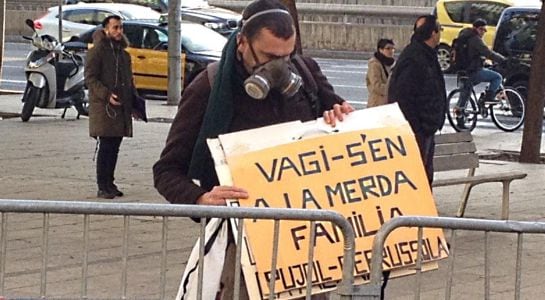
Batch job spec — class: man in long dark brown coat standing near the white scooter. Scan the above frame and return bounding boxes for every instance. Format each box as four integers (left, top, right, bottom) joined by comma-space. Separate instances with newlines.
85, 16, 135, 199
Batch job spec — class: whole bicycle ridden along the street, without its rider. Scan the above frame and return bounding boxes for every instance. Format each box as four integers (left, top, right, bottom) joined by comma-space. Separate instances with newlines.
447, 72, 526, 132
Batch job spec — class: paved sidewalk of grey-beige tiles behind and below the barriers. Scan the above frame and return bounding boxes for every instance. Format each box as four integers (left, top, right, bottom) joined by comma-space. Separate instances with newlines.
0, 95, 545, 299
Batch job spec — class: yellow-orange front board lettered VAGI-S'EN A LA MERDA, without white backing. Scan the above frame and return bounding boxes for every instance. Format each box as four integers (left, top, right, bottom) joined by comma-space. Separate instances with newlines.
221, 120, 448, 294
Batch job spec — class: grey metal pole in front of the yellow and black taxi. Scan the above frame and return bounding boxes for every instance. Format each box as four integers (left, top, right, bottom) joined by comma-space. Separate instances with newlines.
167, 0, 182, 105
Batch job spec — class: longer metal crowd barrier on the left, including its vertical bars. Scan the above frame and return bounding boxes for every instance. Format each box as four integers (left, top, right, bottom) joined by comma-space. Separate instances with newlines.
0, 199, 354, 299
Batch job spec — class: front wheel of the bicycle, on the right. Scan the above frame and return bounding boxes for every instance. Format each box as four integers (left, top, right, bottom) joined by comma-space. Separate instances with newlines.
490, 87, 526, 131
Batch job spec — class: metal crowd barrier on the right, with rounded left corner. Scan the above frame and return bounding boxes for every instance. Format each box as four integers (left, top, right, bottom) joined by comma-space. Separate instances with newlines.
358, 216, 545, 299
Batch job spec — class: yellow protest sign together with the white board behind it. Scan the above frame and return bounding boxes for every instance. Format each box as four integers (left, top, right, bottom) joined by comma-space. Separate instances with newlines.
208, 104, 448, 299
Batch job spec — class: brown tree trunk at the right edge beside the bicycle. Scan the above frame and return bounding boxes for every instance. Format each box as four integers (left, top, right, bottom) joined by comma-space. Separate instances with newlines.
520, 1, 545, 163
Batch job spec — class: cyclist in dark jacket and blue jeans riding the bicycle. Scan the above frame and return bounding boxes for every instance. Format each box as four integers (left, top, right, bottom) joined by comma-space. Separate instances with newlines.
458, 19, 507, 125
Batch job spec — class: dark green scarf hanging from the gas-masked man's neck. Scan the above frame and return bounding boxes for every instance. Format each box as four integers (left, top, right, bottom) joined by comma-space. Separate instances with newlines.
188, 31, 238, 190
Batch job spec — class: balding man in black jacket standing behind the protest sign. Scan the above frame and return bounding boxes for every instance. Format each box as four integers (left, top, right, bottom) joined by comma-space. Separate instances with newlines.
388, 15, 447, 185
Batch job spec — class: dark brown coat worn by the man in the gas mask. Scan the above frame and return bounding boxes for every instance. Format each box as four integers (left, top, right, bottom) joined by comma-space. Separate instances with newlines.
153, 57, 344, 204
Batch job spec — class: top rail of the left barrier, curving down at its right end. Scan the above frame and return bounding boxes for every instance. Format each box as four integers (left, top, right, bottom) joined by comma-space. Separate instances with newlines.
0, 199, 355, 299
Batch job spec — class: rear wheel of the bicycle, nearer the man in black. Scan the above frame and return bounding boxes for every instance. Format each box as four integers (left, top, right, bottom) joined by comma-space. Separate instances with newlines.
447, 89, 479, 132
